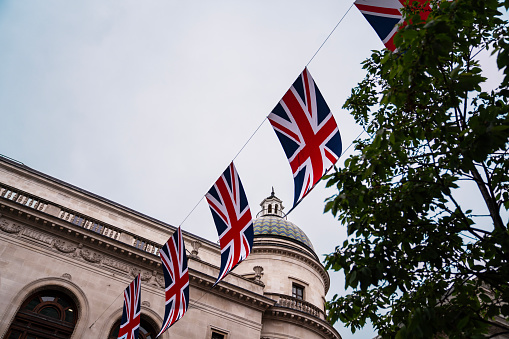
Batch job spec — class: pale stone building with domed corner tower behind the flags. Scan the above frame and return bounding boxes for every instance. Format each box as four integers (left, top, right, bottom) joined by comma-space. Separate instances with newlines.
0, 157, 341, 339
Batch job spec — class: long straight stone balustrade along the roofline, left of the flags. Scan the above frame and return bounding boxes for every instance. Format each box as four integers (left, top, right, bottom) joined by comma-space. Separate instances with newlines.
0, 183, 161, 254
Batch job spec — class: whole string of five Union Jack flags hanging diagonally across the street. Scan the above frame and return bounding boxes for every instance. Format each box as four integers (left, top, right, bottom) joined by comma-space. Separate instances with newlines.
118, 0, 431, 339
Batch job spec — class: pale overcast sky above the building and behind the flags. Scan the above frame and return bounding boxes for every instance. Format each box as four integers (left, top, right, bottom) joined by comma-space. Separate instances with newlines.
0, 0, 504, 339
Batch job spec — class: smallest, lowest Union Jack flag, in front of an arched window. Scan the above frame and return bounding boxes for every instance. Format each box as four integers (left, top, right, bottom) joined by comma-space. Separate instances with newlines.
118, 274, 141, 339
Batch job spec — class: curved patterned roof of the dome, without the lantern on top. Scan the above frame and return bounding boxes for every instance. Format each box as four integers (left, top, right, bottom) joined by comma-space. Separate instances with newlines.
253, 215, 314, 251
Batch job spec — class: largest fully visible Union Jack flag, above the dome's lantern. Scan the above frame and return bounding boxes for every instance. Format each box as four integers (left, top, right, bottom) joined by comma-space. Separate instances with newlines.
269, 68, 342, 207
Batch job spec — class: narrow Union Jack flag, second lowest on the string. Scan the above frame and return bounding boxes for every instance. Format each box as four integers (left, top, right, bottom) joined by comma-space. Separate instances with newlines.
156, 227, 189, 337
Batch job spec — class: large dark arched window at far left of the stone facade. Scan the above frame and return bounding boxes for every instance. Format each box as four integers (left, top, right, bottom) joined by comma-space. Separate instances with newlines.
6, 290, 78, 339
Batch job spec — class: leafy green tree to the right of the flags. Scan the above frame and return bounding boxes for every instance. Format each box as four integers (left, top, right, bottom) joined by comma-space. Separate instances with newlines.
325, 0, 509, 338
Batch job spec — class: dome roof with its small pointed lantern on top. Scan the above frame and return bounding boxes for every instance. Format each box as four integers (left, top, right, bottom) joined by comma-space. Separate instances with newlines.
253, 189, 314, 252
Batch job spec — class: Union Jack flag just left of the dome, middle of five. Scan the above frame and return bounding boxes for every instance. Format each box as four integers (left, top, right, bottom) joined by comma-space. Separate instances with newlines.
205, 162, 254, 285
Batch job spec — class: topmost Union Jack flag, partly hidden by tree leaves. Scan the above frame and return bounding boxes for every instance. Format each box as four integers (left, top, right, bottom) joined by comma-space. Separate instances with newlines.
354, 0, 431, 52
